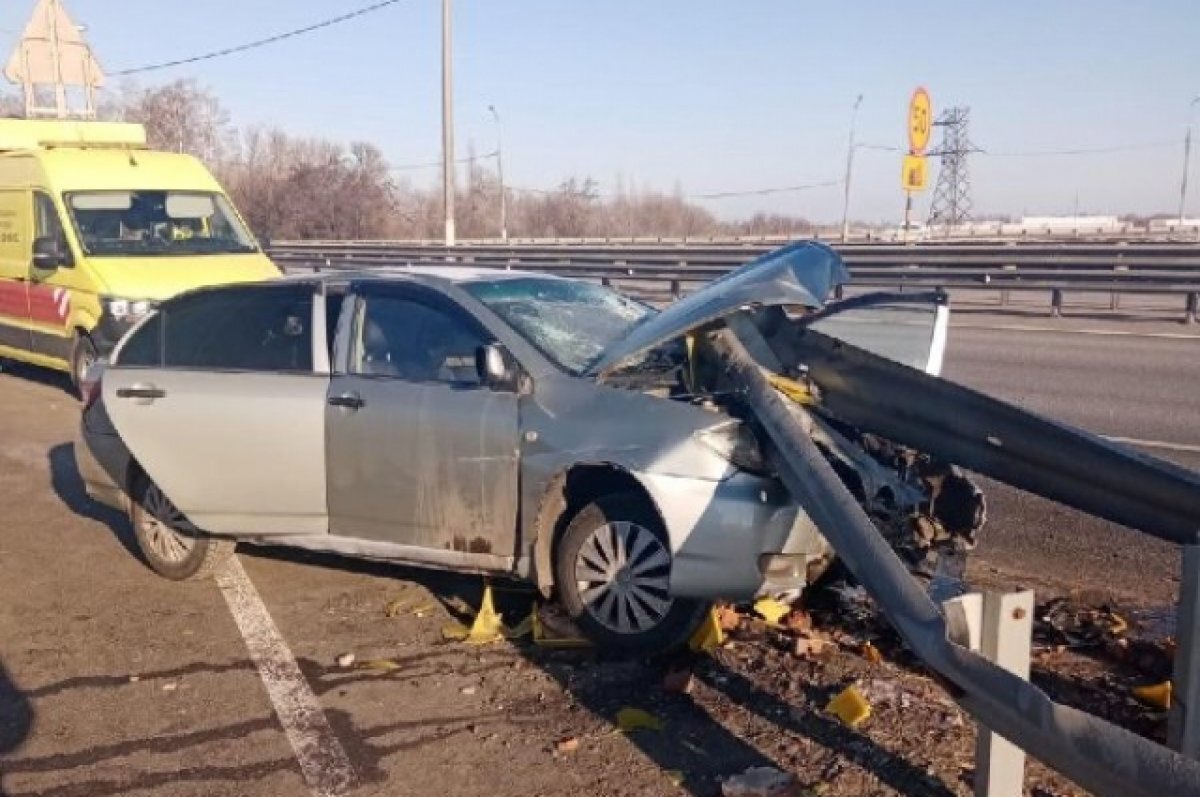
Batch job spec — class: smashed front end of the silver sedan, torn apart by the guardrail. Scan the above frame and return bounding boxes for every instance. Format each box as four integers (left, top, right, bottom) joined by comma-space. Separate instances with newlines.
585, 244, 986, 599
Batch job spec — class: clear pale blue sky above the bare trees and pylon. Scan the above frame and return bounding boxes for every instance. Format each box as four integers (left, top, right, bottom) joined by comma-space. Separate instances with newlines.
0, 0, 1200, 221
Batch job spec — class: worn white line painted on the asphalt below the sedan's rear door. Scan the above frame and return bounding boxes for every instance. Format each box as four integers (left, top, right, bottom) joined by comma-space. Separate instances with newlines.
217, 557, 358, 797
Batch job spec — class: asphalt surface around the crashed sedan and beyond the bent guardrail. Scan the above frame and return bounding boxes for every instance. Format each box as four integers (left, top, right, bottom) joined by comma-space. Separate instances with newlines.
0, 317, 1200, 797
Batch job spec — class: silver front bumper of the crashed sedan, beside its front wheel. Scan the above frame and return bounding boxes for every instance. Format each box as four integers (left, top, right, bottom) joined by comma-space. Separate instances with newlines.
636, 473, 833, 600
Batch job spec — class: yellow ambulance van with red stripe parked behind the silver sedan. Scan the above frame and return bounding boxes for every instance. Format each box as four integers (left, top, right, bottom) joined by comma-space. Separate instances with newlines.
0, 119, 280, 384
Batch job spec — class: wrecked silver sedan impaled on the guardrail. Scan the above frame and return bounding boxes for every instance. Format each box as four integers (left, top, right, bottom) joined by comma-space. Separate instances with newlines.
77, 244, 974, 649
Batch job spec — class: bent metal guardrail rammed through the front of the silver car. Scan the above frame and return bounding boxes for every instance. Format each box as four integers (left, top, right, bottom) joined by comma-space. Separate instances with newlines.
709, 308, 1200, 797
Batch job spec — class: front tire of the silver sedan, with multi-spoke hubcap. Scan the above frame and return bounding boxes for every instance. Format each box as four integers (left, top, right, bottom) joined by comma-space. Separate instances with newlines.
554, 492, 709, 654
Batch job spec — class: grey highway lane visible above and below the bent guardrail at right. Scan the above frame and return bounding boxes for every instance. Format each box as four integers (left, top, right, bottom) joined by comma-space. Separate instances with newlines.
944, 319, 1200, 604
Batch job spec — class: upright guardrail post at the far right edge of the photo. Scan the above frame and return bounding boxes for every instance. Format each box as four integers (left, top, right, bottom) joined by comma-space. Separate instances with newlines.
1166, 544, 1200, 759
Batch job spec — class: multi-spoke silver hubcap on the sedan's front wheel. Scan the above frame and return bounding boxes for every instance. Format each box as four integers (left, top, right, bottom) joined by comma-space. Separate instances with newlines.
575, 521, 673, 634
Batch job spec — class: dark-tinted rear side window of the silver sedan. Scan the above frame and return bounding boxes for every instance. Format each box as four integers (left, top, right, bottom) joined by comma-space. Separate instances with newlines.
118, 286, 313, 373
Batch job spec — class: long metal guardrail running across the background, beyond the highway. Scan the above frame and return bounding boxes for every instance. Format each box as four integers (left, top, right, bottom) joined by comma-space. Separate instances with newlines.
270, 240, 1200, 323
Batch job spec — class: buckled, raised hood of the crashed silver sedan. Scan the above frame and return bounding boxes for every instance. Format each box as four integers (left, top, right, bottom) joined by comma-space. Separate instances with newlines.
584, 241, 850, 376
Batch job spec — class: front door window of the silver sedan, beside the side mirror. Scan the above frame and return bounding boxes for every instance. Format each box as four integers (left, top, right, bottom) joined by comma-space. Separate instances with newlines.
350, 295, 488, 385
